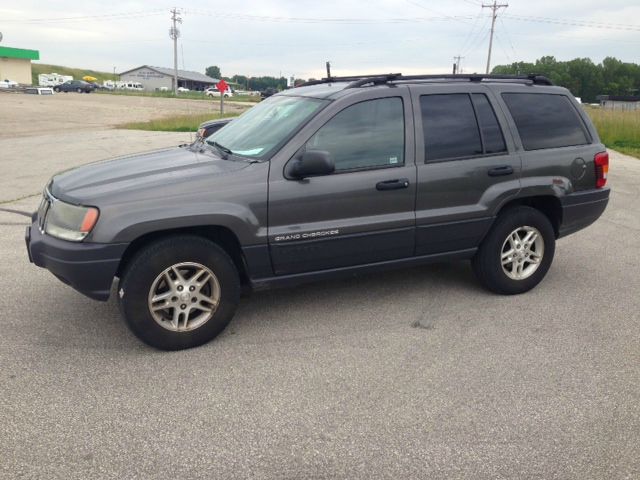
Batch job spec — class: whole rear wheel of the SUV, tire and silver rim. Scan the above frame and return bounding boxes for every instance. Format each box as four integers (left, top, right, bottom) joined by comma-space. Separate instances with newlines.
472, 206, 555, 295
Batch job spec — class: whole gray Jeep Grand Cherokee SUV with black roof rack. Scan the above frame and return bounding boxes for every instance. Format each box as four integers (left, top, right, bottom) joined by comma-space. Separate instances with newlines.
26, 74, 609, 350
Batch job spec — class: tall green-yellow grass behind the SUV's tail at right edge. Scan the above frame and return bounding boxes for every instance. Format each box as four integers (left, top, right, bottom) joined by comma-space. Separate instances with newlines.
586, 107, 640, 158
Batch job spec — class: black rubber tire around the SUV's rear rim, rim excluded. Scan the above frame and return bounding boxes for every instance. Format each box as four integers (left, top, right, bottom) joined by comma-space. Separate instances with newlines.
471, 206, 555, 295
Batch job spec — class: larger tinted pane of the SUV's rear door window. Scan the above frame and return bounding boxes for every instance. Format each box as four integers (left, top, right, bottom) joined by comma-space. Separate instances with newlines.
420, 93, 482, 160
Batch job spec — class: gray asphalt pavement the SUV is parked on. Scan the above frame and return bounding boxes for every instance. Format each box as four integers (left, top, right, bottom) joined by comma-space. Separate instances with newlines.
0, 145, 640, 479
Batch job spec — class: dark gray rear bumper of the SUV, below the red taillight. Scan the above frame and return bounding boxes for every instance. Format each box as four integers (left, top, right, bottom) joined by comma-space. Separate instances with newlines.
558, 188, 611, 238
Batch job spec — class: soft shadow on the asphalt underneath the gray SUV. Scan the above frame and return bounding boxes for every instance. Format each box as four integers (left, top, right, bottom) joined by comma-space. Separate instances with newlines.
35, 262, 486, 354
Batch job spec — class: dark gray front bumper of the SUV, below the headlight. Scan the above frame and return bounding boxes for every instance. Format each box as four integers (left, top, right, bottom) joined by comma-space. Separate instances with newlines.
25, 222, 128, 301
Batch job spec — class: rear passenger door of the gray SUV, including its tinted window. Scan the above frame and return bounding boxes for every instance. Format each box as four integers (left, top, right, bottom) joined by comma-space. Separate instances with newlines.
412, 84, 521, 255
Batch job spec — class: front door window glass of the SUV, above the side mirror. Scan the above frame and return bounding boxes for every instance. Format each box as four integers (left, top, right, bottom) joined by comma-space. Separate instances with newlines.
306, 97, 404, 171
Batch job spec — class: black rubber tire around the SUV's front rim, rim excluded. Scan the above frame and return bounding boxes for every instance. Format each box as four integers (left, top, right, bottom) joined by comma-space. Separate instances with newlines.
118, 235, 240, 350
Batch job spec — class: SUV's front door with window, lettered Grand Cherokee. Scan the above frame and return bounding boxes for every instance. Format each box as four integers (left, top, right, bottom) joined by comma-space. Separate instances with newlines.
269, 88, 416, 275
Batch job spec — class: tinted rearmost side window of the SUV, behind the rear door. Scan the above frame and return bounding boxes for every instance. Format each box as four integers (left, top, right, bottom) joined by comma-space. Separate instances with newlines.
502, 93, 589, 150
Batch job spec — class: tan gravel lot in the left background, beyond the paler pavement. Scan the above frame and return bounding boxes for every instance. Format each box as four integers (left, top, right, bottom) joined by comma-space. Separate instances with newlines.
0, 93, 246, 138
